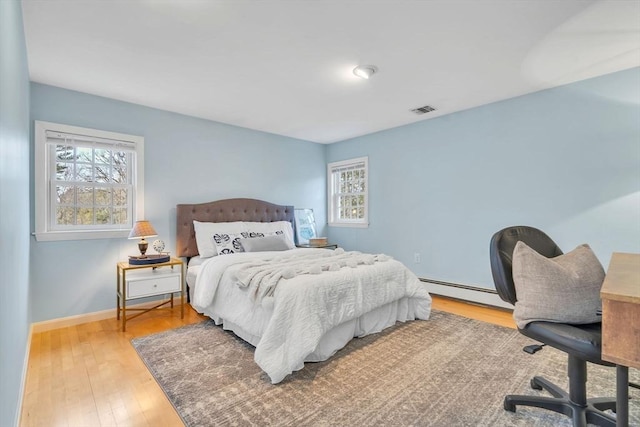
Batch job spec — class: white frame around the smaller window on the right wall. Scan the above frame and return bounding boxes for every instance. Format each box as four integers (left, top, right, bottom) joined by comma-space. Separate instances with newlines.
327, 156, 369, 228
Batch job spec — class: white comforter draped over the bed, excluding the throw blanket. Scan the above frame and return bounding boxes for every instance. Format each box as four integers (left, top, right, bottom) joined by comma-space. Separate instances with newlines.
192, 249, 431, 384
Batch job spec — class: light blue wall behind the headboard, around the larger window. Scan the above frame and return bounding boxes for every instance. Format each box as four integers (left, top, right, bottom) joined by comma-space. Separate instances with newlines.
31, 83, 326, 322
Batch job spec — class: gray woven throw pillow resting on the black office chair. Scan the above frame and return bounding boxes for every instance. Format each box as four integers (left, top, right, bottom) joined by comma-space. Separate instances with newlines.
513, 242, 605, 328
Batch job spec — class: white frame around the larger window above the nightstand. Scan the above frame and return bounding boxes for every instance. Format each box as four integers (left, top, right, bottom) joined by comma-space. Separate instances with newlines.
34, 120, 144, 241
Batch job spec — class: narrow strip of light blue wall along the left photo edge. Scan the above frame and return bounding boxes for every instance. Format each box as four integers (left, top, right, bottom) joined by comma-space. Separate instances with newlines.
0, 0, 31, 426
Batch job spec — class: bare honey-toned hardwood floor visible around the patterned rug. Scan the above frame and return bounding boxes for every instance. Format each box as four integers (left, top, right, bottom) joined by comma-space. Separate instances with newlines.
20, 296, 515, 427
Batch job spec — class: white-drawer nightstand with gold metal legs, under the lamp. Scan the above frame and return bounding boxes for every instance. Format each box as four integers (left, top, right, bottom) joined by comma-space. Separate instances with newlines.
116, 258, 184, 332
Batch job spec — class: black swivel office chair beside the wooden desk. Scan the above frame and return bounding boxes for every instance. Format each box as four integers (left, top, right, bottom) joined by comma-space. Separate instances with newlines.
489, 226, 616, 427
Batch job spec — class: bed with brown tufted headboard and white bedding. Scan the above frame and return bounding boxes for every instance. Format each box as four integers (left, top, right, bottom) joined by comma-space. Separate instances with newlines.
176, 199, 431, 384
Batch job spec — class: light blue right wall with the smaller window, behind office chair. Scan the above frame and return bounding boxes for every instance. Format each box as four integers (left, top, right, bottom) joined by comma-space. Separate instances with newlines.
326, 68, 640, 288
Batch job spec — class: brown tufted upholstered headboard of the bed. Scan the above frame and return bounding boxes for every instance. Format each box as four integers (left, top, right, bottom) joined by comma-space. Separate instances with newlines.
176, 199, 295, 258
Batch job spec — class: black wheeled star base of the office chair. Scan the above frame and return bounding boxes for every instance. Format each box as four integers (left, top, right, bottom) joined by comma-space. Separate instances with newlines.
504, 377, 616, 427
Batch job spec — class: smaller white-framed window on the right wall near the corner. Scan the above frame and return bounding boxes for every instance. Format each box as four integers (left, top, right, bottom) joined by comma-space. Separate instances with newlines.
327, 157, 369, 227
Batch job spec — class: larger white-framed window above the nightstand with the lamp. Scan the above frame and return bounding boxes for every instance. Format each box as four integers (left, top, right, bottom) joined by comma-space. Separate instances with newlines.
35, 121, 144, 241
